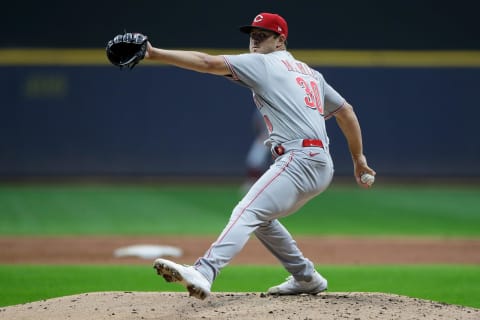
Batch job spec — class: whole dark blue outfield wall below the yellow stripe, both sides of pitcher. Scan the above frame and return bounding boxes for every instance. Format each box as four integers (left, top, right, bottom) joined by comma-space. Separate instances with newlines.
0, 53, 480, 177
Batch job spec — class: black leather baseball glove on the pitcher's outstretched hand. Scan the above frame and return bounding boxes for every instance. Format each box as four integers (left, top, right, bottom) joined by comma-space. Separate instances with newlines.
106, 32, 148, 69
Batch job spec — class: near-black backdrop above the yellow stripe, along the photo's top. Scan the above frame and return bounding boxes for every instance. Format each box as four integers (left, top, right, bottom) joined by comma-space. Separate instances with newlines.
0, 0, 480, 50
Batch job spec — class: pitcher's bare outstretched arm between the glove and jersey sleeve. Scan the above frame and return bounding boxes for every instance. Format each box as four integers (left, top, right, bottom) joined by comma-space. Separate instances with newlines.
145, 42, 231, 76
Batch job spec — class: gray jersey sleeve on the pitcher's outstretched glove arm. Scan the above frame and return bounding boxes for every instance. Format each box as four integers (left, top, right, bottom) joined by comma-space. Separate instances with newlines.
223, 53, 266, 89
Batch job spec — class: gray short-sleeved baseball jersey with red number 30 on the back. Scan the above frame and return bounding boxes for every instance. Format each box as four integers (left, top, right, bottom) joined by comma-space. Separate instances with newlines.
224, 51, 345, 146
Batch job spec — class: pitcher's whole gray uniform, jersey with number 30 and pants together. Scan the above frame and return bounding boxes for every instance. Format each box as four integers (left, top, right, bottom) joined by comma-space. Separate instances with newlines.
195, 51, 345, 282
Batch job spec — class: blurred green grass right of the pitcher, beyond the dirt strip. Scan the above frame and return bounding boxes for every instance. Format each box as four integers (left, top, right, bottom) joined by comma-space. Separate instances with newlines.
285, 186, 480, 237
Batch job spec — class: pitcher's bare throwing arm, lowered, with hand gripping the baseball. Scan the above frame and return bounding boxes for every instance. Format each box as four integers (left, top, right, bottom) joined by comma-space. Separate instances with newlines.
335, 102, 376, 187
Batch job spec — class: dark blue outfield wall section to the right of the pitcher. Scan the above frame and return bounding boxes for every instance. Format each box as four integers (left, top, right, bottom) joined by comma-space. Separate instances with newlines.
322, 68, 480, 176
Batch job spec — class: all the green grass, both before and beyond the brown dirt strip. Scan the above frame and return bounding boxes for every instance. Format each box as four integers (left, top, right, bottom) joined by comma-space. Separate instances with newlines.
0, 183, 480, 308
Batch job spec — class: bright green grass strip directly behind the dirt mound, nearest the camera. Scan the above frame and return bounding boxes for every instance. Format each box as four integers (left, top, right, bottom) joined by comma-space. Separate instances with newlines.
0, 265, 480, 308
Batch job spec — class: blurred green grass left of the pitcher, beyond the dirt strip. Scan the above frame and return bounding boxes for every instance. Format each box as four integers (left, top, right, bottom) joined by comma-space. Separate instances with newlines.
0, 186, 237, 235
